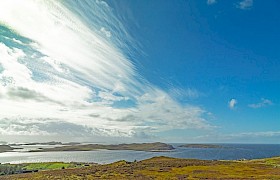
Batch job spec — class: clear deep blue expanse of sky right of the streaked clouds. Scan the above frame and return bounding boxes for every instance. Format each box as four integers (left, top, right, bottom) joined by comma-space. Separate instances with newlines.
109, 0, 280, 141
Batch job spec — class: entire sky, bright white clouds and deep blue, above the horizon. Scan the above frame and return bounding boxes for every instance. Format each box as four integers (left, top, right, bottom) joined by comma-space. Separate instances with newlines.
0, 0, 280, 144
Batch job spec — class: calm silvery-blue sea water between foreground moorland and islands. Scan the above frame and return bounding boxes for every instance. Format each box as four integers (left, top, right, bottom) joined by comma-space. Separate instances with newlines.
0, 144, 280, 164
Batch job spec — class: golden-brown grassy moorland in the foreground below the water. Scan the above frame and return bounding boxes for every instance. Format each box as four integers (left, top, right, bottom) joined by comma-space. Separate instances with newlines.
0, 157, 280, 180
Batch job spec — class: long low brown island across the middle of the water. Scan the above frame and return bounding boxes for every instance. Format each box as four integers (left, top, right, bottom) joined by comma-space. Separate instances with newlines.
30, 142, 174, 152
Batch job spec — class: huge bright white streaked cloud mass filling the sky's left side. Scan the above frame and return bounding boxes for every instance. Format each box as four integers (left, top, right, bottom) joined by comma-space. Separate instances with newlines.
0, 0, 213, 142
